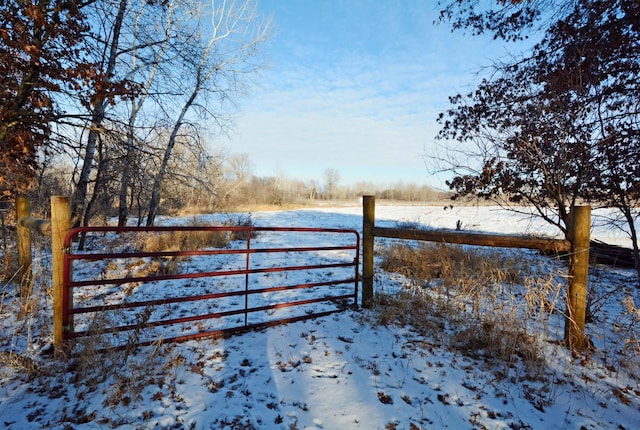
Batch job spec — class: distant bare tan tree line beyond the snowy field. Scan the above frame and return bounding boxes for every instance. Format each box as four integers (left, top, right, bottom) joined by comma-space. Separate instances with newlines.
28, 155, 450, 220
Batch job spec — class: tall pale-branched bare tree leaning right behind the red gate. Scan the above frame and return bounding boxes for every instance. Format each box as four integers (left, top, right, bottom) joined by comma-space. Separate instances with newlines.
146, 0, 269, 226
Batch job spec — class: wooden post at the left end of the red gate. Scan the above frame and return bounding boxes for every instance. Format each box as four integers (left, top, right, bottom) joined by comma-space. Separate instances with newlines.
51, 196, 71, 351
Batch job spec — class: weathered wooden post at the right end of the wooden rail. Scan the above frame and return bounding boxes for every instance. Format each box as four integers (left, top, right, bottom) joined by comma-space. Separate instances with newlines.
564, 206, 591, 350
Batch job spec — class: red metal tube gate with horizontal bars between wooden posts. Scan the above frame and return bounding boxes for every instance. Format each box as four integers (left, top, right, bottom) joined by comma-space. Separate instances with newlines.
62, 226, 360, 347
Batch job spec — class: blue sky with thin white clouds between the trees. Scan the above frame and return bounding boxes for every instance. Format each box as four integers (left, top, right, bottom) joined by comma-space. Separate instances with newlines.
220, 0, 513, 187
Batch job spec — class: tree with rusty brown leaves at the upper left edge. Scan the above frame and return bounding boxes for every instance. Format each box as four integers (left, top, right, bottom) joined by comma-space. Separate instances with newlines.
0, 0, 89, 195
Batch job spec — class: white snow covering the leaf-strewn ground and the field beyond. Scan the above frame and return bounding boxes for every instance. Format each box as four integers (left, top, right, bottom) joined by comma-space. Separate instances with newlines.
0, 204, 640, 430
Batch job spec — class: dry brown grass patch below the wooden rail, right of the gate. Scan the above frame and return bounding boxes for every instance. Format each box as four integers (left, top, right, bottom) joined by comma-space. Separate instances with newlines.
376, 244, 562, 378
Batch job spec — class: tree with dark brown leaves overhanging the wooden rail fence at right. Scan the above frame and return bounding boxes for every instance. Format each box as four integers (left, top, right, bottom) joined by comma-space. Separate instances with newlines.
439, 0, 640, 277
